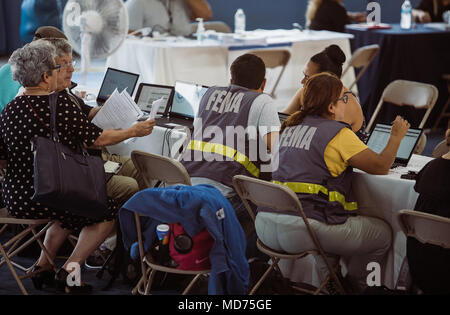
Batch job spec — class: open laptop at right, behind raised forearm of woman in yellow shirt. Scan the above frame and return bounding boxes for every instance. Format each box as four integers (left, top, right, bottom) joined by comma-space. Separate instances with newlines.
367, 124, 423, 168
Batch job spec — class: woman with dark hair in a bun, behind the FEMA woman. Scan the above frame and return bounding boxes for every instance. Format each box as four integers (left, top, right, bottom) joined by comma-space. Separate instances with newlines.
283, 45, 368, 142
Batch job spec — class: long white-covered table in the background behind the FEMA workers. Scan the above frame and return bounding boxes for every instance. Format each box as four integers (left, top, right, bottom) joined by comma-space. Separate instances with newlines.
106, 30, 355, 108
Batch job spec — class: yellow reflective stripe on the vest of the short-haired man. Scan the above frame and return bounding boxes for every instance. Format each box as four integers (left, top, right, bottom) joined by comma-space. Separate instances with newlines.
188, 140, 260, 177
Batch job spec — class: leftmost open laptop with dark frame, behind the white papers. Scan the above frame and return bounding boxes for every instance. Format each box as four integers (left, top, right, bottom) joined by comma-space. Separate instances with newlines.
97, 68, 139, 106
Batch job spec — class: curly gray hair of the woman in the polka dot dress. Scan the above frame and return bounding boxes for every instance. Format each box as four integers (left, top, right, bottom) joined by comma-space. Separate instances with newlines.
8, 40, 57, 87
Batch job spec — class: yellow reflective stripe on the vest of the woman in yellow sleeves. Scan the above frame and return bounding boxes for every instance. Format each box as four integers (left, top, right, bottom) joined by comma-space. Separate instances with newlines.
272, 180, 358, 211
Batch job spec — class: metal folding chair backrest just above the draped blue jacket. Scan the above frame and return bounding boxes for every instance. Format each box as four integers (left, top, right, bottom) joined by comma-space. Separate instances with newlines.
131, 150, 191, 187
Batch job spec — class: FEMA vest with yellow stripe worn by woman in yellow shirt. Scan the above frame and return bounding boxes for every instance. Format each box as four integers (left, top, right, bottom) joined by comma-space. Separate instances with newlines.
263, 116, 358, 224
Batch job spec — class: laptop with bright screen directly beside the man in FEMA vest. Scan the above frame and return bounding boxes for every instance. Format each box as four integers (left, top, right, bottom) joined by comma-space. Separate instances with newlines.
156, 81, 208, 129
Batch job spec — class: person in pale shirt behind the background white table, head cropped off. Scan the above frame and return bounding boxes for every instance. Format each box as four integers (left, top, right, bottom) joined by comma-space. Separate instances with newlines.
125, 0, 212, 36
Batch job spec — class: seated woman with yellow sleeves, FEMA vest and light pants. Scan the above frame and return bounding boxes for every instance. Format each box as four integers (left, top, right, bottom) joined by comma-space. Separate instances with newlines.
255, 73, 409, 293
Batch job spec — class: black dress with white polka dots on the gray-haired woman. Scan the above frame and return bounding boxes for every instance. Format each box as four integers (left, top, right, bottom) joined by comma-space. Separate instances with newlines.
0, 95, 118, 231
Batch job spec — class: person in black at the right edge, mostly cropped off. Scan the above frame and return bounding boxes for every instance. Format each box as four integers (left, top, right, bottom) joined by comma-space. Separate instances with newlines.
406, 139, 450, 295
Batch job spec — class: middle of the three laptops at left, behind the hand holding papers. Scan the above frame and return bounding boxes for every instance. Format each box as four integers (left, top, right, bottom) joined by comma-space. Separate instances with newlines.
134, 83, 175, 118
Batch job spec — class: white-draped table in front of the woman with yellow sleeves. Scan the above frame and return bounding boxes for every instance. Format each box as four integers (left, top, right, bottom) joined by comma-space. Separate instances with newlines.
280, 155, 432, 289
